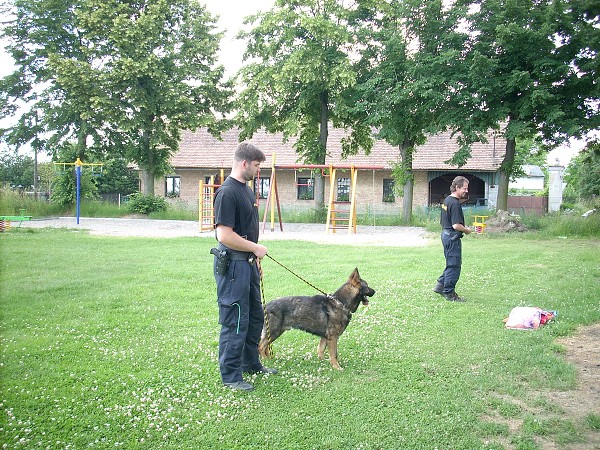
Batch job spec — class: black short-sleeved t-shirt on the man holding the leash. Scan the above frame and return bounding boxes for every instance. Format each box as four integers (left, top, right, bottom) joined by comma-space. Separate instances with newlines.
215, 177, 259, 242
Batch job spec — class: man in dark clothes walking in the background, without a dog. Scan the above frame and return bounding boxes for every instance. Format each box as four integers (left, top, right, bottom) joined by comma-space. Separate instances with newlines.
433, 176, 471, 302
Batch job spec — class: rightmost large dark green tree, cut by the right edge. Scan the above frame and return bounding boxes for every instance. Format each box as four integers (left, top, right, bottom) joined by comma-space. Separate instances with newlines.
446, 0, 600, 209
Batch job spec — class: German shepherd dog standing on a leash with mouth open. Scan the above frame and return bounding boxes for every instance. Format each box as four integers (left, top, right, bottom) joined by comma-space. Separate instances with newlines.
258, 269, 375, 370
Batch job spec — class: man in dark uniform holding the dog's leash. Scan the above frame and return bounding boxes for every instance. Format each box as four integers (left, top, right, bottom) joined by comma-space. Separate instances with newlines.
213, 142, 277, 391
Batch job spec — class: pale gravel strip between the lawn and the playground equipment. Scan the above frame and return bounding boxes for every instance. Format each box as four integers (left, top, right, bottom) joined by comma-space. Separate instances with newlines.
18, 217, 437, 247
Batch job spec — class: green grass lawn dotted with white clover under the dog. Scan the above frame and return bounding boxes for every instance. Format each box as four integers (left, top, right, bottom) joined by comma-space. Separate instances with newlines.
0, 229, 600, 449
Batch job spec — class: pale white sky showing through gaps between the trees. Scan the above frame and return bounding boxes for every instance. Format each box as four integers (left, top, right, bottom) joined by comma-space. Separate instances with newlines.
0, 0, 585, 167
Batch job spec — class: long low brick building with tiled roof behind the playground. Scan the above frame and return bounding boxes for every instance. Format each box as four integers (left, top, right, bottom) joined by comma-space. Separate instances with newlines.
146, 129, 506, 214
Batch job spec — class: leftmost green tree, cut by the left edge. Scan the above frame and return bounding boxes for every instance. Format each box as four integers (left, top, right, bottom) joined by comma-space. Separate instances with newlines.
0, 0, 102, 158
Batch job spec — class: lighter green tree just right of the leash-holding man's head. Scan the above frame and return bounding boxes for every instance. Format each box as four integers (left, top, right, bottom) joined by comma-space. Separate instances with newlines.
236, 0, 372, 209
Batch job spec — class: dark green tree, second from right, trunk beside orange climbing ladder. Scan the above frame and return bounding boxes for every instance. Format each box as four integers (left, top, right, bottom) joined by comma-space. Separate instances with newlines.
359, 0, 466, 222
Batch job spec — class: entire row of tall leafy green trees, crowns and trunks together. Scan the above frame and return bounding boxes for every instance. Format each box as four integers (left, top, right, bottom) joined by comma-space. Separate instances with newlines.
0, 0, 600, 215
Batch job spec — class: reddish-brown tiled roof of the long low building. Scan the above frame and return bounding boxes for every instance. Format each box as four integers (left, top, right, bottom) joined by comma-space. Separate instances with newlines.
171, 129, 506, 171
